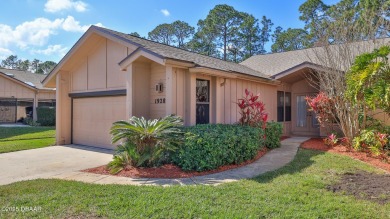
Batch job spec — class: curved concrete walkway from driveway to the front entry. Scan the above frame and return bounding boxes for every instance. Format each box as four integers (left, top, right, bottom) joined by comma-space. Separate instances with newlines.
48, 137, 309, 186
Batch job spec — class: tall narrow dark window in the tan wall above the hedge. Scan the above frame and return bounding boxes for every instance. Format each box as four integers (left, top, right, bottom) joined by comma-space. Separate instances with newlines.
196, 79, 210, 124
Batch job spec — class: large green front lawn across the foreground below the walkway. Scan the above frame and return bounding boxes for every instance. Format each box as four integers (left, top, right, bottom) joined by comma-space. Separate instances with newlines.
0, 149, 390, 218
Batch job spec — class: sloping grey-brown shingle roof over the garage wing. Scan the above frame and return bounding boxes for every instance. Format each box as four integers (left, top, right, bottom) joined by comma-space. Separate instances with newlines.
91, 26, 270, 79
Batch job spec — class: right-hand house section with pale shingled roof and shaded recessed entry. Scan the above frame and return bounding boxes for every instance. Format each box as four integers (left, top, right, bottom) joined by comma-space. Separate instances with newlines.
240, 38, 390, 136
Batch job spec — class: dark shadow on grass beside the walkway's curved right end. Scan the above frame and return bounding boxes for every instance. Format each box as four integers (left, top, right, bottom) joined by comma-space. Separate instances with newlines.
250, 148, 325, 183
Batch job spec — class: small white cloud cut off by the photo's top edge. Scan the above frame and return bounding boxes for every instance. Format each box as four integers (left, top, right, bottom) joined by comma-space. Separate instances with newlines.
45, 0, 87, 13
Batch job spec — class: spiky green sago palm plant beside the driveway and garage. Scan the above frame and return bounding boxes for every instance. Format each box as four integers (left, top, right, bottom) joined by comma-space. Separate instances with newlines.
108, 115, 183, 172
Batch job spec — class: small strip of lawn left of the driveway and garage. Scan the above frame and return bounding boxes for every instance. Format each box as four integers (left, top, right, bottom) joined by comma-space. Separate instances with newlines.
0, 127, 55, 153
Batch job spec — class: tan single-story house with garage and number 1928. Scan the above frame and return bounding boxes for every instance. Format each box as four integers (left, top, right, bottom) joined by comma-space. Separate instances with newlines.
43, 26, 388, 148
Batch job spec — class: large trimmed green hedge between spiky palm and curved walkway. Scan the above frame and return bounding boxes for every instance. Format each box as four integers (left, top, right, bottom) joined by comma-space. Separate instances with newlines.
172, 124, 264, 171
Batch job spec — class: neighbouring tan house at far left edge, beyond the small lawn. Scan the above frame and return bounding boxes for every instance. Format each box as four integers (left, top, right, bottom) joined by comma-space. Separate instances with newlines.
0, 68, 56, 123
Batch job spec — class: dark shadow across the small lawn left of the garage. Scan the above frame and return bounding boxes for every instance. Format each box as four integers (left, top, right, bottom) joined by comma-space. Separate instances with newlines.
0, 127, 55, 141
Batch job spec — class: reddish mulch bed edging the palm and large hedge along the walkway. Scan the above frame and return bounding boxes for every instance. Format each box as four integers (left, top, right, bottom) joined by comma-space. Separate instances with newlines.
83, 148, 268, 179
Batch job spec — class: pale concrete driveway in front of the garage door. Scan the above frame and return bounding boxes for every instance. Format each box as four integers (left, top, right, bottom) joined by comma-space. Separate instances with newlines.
0, 145, 113, 185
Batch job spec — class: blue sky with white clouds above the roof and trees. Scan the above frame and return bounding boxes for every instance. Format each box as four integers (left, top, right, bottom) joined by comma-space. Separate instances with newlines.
0, 0, 337, 62
